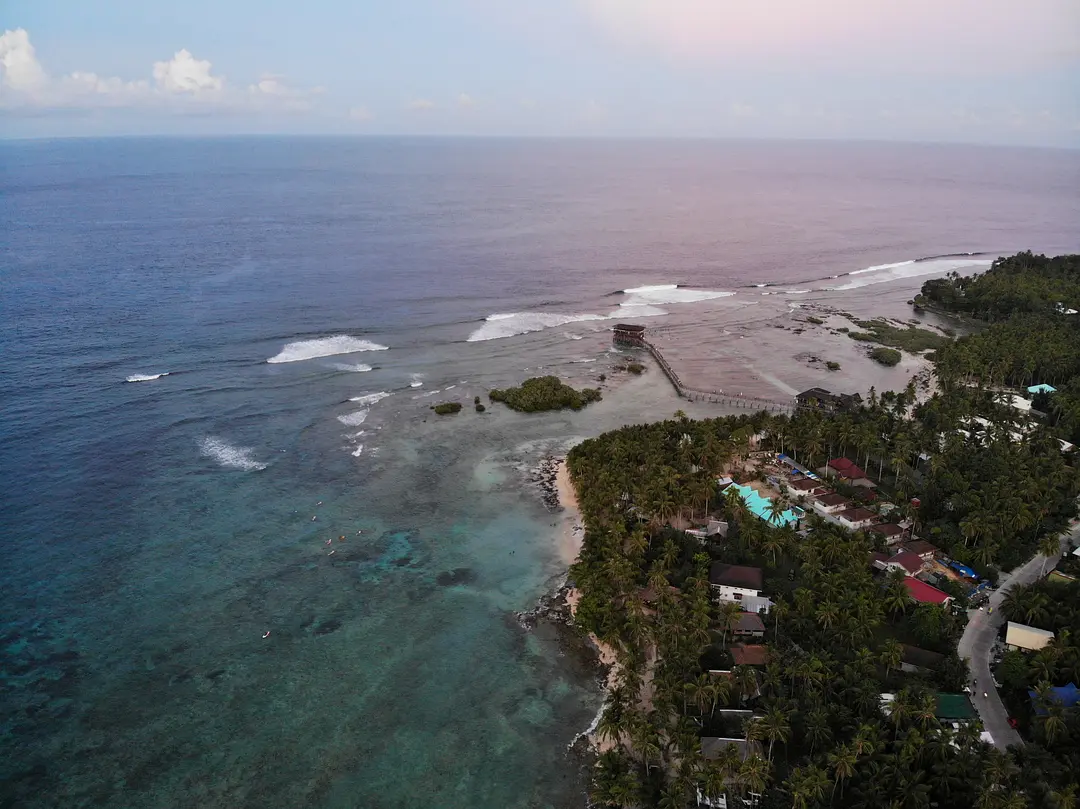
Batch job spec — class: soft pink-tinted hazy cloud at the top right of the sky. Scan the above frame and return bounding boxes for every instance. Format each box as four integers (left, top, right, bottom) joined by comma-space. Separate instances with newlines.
576, 0, 1080, 73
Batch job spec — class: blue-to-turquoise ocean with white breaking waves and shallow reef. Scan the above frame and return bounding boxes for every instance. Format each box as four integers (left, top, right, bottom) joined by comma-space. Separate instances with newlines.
0, 138, 1080, 809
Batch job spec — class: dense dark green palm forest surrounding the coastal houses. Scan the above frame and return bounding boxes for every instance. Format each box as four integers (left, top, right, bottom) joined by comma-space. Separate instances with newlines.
568, 250, 1080, 809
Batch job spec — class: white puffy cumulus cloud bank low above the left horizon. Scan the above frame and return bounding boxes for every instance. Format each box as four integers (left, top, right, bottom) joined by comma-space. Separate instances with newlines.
0, 28, 321, 110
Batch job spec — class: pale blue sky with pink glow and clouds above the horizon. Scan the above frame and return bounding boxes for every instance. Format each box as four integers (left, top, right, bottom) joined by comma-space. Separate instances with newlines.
0, 0, 1080, 148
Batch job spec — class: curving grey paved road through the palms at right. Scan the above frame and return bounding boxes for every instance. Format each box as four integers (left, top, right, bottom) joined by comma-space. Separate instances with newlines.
957, 526, 1080, 750
